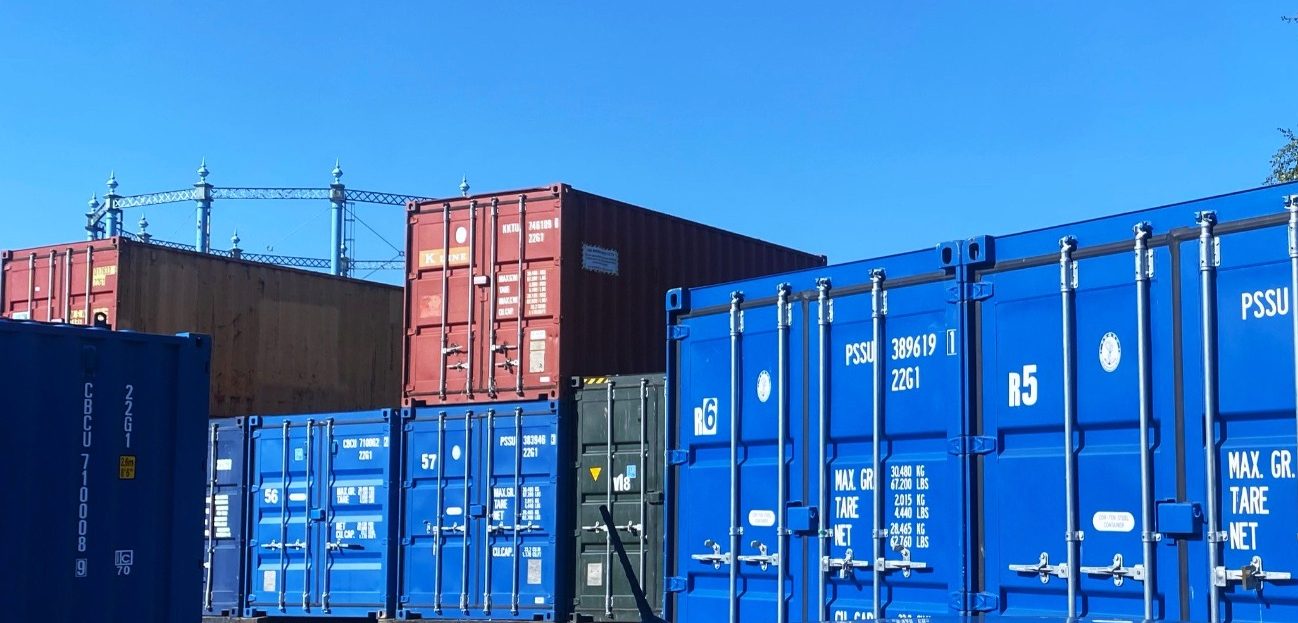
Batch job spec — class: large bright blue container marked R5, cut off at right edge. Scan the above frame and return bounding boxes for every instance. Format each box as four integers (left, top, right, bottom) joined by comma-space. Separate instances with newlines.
976, 184, 1298, 622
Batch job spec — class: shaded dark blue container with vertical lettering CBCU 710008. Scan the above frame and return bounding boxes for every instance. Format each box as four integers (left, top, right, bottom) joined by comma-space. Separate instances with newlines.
0, 321, 210, 623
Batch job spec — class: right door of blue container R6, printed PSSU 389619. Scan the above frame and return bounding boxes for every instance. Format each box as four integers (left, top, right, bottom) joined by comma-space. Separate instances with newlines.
805, 270, 966, 620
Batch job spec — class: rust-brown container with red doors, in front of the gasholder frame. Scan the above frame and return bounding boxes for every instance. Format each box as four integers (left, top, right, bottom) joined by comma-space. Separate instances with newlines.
0, 238, 402, 417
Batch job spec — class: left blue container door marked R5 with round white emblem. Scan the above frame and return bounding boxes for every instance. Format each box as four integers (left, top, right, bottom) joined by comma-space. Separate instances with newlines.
976, 232, 1184, 620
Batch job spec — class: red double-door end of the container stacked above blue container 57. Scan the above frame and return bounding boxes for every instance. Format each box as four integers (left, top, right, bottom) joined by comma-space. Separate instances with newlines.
406, 195, 561, 404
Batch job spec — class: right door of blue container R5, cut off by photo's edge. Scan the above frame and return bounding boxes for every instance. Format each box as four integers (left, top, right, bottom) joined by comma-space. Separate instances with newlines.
1181, 211, 1298, 622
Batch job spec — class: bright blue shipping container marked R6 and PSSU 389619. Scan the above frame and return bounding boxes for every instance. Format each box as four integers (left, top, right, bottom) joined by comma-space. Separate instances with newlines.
666, 250, 968, 623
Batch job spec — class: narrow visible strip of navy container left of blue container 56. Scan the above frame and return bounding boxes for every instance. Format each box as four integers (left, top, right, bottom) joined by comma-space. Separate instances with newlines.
202, 418, 248, 617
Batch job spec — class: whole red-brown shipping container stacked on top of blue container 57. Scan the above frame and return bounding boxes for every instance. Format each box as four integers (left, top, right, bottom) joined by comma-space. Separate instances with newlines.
404, 184, 824, 405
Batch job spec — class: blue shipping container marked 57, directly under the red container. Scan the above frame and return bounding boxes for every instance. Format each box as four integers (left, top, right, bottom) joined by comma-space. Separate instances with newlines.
397, 401, 574, 620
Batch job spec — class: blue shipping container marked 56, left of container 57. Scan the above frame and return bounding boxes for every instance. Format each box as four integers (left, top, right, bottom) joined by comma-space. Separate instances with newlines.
244, 410, 400, 618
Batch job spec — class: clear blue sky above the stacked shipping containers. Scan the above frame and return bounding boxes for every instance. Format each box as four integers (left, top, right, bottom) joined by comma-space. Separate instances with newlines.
0, 1, 1298, 280
